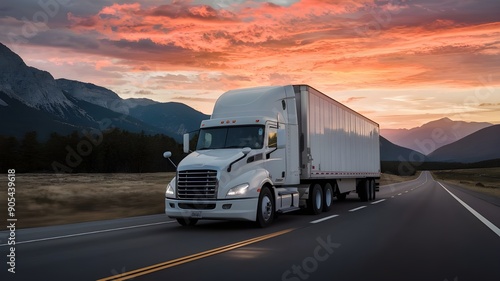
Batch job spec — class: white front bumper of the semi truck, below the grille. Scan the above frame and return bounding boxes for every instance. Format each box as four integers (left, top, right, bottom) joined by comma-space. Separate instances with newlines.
165, 198, 258, 221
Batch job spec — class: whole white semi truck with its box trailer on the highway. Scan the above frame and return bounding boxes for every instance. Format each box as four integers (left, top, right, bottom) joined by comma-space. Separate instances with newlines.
164, 85, 380, 227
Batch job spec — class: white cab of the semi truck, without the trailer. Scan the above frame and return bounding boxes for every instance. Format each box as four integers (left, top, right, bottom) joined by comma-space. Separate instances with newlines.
165, 86, 300, 227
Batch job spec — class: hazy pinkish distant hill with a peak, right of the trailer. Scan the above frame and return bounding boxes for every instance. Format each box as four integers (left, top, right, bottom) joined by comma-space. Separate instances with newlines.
380, 118, 492, 155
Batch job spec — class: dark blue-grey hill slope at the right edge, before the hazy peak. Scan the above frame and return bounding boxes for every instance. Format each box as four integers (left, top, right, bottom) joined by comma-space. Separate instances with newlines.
428, 125, 500, 163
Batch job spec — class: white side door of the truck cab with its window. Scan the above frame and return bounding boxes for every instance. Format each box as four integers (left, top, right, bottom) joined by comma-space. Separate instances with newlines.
264, 122, 287, 185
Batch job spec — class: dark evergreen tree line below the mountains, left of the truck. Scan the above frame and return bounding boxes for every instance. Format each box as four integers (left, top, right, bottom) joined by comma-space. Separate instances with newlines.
0, 128, 184, 173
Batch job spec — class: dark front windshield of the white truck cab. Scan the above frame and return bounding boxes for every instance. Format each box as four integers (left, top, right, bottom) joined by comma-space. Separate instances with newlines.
196, 125, 264, 150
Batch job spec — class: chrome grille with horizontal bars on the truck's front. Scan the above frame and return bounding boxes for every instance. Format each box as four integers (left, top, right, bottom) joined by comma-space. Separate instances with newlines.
177, 170, 217, 200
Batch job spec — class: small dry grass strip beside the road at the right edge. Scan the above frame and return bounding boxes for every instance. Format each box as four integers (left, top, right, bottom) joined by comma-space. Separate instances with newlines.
432, 168, 500, 198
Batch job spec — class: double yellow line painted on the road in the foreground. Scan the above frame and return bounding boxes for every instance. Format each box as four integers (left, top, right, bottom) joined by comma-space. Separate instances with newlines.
97, 228, 295, 281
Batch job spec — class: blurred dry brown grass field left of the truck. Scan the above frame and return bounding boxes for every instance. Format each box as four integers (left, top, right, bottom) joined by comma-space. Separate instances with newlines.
0, 173, 175, 228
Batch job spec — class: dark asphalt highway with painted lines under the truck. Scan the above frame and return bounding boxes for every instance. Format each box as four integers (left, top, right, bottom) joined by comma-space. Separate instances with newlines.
0, 172, 500, 281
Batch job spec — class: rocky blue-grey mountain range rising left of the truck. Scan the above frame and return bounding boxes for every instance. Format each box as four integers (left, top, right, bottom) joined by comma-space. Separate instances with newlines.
0, 43, 209, 141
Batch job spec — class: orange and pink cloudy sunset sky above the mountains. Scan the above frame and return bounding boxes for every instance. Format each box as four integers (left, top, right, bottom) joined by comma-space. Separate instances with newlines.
0, 0, 500, 128
